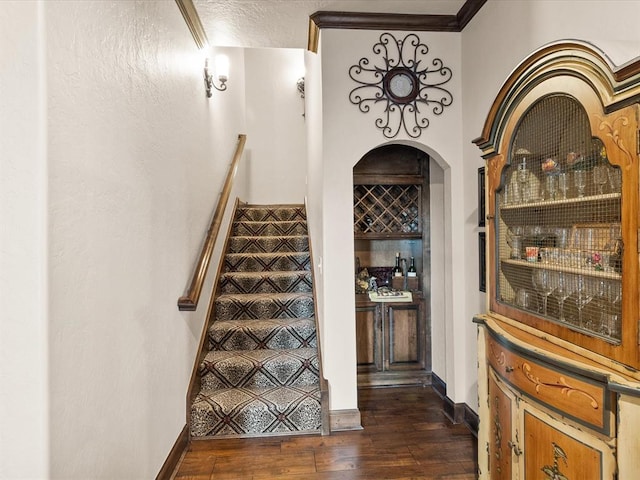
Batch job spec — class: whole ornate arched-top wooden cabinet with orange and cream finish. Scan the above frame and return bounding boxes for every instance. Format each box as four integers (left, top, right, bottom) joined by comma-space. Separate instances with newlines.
474, 43, 640, 480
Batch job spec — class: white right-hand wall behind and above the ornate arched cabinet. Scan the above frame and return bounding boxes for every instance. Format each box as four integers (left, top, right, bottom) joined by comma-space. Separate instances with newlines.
454, 0, 640, 408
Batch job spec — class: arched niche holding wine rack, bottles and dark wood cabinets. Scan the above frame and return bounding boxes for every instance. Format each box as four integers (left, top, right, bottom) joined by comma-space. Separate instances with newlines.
353, 144, 431, 386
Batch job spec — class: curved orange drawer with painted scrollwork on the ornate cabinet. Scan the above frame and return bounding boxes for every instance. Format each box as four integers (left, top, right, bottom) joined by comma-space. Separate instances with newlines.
487, 336, 612, 435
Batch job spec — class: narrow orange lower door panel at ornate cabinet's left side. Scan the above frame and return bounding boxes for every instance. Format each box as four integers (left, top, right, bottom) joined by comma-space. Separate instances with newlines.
488, 374, 513, 480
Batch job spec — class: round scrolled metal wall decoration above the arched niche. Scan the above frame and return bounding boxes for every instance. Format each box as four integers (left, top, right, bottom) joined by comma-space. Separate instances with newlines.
349, 32, 453, 138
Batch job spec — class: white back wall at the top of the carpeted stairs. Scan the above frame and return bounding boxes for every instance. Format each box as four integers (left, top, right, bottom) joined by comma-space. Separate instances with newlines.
245, 48, 307, 204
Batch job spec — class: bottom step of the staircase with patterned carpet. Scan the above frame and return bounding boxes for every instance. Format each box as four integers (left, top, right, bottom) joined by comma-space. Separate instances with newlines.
190, 385, 321, 437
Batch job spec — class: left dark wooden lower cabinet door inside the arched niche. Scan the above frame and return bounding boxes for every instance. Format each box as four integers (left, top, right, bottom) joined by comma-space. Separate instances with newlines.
356, 305, 382, 372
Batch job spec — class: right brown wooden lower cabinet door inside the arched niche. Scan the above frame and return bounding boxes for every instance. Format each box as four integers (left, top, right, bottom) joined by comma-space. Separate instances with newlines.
388, 304, 424, 368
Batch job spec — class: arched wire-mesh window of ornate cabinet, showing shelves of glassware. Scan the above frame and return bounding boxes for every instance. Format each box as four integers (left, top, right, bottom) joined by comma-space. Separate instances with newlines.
493, 93, 637, 360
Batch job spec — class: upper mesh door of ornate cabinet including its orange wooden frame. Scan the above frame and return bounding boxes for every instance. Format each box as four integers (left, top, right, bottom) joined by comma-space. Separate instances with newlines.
480, 68, 640, 369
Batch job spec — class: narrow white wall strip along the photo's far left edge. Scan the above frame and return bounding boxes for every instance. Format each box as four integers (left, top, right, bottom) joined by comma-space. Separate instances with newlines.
0, 2, 49, 479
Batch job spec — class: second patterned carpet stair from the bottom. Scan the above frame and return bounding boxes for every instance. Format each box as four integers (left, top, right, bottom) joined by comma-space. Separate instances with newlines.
199, 348, 320, 390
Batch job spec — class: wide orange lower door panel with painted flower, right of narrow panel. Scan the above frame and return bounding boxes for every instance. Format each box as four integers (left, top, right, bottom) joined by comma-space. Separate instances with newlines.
524, 408, 615, 480
